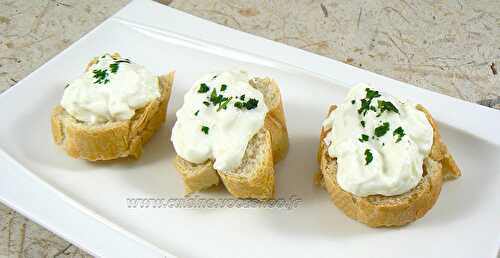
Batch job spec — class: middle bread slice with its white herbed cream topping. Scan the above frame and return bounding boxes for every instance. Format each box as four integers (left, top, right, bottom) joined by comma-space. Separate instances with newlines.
171, 71, 288, 199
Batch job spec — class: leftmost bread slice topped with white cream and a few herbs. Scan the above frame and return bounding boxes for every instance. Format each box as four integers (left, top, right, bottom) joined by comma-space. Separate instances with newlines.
51, 53, 174, 161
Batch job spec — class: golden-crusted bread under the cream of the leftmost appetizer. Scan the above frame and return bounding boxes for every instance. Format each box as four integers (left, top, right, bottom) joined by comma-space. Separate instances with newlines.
51, 61, 174, 161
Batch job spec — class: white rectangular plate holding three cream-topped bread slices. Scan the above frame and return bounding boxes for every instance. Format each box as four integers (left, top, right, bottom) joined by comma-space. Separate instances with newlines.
0, 1, 500, 257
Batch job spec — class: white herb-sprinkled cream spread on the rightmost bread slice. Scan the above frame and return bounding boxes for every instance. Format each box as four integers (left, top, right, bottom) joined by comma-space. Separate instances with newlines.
323, 84, 433, 196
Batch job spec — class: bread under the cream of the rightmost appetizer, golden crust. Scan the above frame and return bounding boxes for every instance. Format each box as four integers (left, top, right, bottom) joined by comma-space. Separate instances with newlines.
316, 105, 461, 227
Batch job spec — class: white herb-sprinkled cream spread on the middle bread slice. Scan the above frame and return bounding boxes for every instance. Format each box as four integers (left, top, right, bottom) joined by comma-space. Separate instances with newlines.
171, 71, 267, 171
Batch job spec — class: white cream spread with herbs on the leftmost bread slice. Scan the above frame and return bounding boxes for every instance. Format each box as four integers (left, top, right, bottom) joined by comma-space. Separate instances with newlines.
61, 54, 160, 124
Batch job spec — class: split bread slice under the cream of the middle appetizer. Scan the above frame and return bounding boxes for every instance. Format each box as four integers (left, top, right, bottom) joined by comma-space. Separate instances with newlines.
175, 78, 288, 200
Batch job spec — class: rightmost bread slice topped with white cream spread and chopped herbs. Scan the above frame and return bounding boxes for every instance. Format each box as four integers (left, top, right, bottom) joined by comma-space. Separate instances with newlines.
317, 84, 461, 227
